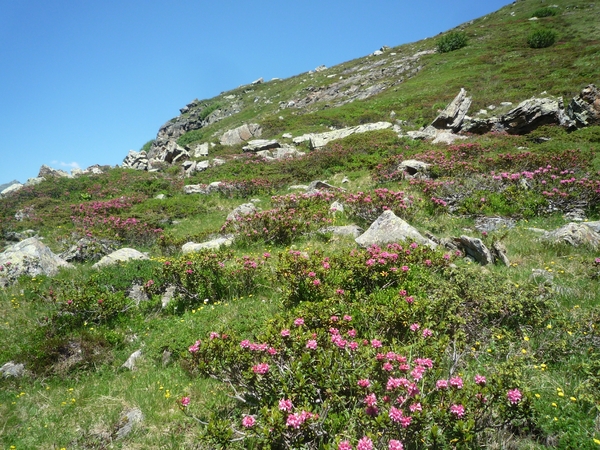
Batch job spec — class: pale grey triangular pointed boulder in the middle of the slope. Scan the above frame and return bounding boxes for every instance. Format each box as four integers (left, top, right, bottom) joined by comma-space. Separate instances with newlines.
356, 210, 437, 248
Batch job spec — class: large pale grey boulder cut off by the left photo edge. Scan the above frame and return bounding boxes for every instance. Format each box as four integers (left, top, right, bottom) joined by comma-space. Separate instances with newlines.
0, 237, 73, 286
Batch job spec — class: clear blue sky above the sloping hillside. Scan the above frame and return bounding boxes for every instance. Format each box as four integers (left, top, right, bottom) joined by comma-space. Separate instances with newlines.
0, 0, 511, 184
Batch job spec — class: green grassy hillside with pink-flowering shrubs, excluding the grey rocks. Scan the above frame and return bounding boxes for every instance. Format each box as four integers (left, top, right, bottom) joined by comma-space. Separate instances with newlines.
0, 0, 600, 449
